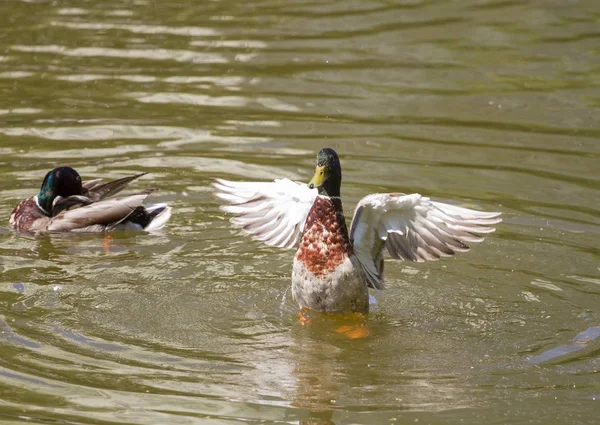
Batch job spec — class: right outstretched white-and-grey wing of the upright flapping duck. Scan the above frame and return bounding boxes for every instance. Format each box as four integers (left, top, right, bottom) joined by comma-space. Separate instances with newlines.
350, 193, 502, 289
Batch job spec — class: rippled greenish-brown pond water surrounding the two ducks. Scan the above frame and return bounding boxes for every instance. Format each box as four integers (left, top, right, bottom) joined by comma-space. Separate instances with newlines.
0, 0, 600, 424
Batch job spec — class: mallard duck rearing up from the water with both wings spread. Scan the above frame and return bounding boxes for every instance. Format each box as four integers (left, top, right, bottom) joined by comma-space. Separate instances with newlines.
213, 148, 502, 314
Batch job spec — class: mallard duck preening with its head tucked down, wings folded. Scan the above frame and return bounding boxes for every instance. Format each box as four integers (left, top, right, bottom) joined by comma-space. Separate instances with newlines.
9, 167, 171, 233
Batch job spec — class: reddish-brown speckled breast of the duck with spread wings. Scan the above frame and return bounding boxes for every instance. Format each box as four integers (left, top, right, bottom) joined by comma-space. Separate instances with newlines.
296, 196, 352, 277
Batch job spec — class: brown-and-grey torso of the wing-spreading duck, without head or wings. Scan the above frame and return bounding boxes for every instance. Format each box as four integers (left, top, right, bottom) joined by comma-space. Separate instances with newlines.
292, 195, 369, 313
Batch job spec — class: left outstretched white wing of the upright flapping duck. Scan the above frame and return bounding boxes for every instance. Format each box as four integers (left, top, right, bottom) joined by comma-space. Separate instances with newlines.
213, 179, 318, 248
